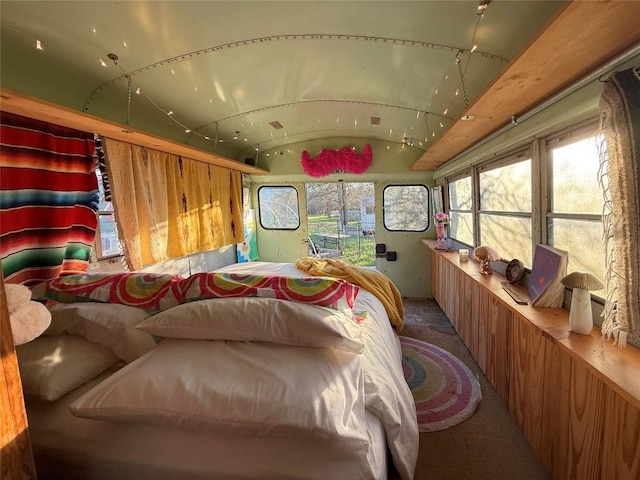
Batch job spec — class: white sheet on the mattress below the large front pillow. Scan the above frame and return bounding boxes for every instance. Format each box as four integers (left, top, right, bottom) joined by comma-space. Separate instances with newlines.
27, 366, 387, 480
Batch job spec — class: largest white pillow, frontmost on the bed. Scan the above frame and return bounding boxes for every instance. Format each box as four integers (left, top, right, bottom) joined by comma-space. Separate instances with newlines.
69, 338, 367, 449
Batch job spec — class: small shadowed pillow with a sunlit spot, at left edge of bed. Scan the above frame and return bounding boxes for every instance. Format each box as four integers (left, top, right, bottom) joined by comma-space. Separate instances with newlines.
16, 335, 119, 402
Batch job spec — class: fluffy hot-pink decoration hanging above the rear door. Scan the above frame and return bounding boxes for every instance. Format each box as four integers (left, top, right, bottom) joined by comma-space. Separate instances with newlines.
300, 144, 373, 177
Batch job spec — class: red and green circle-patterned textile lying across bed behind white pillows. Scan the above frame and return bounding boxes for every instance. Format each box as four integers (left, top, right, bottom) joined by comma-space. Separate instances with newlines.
33, 272, 359, 313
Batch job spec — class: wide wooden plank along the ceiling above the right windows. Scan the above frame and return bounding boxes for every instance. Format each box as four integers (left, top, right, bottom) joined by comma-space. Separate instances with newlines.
412, 1, 640, 171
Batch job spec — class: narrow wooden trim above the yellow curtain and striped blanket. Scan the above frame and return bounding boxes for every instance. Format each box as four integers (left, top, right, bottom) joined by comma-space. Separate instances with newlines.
0, 89, 269, 175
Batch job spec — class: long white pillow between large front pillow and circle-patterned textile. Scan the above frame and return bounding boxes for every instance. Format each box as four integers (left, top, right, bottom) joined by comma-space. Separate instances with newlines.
138, 297, 364, 353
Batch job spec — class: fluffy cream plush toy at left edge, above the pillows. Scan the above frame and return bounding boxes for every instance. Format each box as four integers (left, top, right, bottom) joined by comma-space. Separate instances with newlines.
4, 283, 51, 345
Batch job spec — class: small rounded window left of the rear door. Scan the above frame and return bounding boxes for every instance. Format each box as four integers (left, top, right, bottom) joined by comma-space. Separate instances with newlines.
258, 186, 300, 230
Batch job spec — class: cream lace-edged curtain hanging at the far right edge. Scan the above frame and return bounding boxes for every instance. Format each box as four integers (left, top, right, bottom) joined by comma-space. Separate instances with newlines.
600, 67, 640, 347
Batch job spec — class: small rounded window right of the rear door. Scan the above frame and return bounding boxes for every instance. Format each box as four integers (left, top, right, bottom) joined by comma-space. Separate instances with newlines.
382, 185, 429, 232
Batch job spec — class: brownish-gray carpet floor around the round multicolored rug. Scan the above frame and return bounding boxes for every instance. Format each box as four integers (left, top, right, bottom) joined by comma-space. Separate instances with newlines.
390, 299, 550, 480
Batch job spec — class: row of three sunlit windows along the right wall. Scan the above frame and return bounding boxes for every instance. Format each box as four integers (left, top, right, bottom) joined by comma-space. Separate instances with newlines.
447, 122, 605, 296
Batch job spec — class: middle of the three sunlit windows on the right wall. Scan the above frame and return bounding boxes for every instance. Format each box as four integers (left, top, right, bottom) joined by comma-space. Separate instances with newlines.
478, 155, 533, 267
